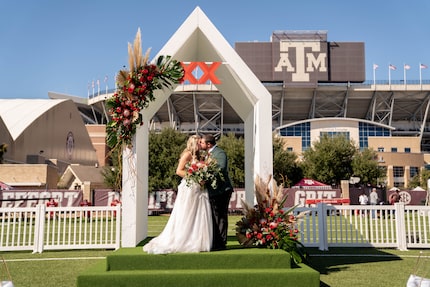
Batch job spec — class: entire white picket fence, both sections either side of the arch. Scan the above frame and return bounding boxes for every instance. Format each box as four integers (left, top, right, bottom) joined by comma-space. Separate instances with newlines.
0, 203, 430, 252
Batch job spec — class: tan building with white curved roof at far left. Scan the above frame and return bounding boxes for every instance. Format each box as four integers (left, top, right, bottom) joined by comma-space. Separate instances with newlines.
0, 99, 99, 189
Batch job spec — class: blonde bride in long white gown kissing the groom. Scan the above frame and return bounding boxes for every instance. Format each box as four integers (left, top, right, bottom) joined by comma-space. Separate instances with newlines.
143, 135, 212, 254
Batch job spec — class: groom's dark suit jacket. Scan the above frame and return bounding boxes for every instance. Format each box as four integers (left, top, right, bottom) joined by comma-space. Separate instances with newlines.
206, 146, 233, 197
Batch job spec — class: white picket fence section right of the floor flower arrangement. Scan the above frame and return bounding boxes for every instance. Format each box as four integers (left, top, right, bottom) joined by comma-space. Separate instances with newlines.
295, 203, 430, 250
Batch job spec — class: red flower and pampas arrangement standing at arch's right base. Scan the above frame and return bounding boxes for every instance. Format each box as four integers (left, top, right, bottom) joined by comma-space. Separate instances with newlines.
236, 176, 306, 263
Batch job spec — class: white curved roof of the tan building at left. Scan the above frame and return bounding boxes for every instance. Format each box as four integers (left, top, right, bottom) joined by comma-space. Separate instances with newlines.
0, 99, 66, 140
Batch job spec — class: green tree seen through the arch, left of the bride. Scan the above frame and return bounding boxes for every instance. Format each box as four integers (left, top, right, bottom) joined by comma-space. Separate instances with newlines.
148, 128, 188, 192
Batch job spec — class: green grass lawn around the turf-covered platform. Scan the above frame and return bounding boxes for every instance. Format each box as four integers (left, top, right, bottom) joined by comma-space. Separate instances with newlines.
0, 216, 430, 287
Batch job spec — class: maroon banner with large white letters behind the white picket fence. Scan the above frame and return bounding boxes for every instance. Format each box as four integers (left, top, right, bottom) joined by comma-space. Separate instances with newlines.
0, 188, 426, 212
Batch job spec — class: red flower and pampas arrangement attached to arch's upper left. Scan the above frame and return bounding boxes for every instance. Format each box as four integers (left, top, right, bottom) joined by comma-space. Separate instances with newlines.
106, 29, 184, 151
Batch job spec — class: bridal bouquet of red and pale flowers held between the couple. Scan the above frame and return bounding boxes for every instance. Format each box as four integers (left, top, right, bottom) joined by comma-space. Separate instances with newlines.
185, 158, 222, 189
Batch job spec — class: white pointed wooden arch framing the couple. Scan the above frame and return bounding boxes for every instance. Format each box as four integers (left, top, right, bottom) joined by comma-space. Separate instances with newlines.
121, 7, 273, 247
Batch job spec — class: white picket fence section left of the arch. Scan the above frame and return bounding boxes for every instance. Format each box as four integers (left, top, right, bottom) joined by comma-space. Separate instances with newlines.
0, 204, 121, 252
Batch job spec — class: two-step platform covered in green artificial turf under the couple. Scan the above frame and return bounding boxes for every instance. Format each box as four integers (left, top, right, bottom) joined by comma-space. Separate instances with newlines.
77, 246, 320, 287
